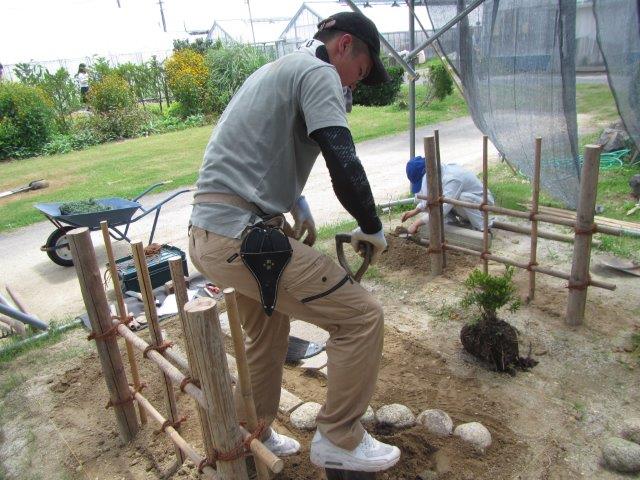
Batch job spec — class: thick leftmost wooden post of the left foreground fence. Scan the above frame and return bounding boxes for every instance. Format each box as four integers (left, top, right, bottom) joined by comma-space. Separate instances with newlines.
67, 228, 138, 442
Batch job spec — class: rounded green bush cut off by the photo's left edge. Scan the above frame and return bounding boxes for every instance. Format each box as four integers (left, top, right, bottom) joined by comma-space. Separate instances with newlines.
0, 82, 55, 158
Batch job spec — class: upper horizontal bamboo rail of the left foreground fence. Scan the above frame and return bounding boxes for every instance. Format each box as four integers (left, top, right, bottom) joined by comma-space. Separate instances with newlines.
113, 320, 284, 473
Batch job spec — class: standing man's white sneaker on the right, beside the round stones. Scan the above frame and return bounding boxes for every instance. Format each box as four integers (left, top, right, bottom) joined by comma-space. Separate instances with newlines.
311, 430, 400, 472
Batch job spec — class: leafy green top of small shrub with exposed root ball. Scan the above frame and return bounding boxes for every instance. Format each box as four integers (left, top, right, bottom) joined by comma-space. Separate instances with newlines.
461, 267, 522, 322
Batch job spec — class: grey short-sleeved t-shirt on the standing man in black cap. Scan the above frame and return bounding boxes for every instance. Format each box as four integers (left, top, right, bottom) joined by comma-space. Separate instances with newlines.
191, 40, 348, 238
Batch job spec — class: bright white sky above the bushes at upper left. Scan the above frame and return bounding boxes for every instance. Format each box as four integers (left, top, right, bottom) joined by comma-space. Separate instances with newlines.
0, 0, 302, 65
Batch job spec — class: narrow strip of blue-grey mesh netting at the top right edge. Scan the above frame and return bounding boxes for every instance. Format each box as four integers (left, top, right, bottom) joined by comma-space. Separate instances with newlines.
593, 0, 640, 147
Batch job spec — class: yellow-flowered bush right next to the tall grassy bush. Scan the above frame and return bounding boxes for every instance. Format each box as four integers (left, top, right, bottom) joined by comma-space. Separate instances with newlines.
165, 49, 209, 118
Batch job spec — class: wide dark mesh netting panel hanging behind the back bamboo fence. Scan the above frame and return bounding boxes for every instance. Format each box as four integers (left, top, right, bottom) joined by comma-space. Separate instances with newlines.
427, 0, 580, 208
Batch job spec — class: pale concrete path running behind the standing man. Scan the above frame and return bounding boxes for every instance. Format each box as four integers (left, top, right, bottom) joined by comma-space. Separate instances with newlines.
0, 117, 497, 321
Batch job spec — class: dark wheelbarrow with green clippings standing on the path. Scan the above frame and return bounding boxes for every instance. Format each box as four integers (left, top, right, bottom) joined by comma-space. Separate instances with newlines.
35, 182, 191, 267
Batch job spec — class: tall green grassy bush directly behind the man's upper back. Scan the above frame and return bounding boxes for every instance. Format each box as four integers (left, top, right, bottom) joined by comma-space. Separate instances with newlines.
206, 45, 270, 113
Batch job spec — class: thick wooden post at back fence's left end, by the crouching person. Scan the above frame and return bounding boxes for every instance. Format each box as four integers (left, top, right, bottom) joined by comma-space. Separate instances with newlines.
424, 137, 443, 276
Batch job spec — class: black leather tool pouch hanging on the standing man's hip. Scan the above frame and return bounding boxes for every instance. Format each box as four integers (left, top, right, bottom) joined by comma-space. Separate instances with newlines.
240, 222, 293, 316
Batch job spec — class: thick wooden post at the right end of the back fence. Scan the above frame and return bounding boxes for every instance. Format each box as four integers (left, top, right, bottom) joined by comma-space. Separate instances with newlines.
565, 145, 602, 325
